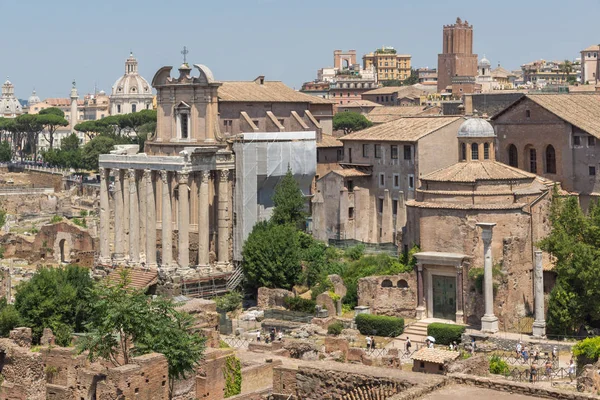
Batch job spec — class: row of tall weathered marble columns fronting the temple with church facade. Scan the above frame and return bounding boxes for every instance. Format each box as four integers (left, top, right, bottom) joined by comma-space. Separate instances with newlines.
100, 168, 229, 268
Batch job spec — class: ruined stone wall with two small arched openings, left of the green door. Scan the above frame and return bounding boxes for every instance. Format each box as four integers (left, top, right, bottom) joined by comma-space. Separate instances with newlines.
357, 272, 417, 318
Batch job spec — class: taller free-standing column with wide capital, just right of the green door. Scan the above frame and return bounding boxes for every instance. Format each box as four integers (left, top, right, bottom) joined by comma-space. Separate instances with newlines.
477, 222, 498, 333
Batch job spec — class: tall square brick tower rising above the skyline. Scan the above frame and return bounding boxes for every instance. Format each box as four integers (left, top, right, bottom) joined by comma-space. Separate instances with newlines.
438, 18, 477, 95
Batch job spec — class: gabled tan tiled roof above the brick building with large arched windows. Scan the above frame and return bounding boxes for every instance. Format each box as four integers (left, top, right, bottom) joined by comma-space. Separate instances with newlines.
492, 94, 600, 138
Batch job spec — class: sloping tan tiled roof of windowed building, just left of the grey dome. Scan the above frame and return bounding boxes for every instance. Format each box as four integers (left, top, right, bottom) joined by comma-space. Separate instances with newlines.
340, 116, 463, 142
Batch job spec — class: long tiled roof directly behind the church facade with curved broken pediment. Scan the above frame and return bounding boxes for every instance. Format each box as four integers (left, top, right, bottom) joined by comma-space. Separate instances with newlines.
218, 81, 334, 104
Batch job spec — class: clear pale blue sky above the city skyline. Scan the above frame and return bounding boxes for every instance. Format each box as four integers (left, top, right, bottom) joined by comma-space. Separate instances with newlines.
0, 0, 600, 99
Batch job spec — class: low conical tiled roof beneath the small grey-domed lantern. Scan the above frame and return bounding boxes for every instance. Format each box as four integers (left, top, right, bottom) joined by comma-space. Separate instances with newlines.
421, 161, 536, 183
